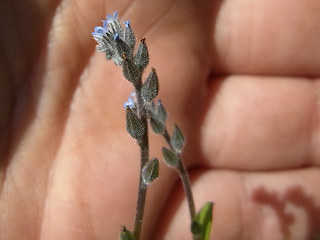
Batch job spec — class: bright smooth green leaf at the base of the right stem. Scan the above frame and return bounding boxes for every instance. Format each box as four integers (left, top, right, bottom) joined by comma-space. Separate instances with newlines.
191, 202, 213, 240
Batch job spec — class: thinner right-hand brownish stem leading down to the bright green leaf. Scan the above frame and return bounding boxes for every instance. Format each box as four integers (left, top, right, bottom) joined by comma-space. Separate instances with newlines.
163, 129, 196, 221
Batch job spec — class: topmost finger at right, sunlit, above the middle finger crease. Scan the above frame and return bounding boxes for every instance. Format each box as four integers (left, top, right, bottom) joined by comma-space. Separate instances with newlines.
212, 0, 320, 76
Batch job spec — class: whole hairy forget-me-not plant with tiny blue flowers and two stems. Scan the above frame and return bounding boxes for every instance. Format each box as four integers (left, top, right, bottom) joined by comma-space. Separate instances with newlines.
92, 11, 213, 240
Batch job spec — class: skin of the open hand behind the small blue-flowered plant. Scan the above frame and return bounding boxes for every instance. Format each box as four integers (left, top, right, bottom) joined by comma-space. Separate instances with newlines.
0, 0, 320, 240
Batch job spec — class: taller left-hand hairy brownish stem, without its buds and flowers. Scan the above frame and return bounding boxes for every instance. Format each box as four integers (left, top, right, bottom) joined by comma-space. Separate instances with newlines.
133, 84, 149, 240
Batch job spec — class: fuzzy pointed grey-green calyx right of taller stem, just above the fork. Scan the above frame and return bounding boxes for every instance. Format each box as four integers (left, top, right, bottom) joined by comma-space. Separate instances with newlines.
141, 68, 159, 102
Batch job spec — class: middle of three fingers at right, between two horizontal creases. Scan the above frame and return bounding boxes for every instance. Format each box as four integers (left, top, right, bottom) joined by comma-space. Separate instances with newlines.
200, 76, 320, 170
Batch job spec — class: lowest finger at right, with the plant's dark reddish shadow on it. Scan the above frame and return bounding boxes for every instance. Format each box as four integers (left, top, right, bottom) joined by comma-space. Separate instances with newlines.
157, 168, 320, 240
